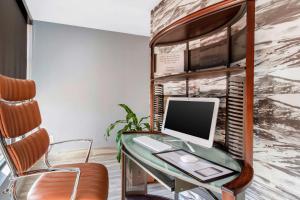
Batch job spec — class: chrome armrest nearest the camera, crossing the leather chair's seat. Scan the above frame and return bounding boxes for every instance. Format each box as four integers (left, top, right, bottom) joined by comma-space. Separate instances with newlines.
7, 168, 80, 200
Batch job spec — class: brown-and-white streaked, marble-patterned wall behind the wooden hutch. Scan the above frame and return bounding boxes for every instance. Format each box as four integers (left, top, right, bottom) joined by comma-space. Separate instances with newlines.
152, 0, 300, 200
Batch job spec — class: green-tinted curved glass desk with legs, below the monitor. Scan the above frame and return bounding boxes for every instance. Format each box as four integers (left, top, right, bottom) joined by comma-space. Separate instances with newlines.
122, 133, 242, 199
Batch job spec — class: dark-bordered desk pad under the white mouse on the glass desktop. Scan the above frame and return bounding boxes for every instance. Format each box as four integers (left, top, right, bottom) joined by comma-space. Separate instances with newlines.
157, 150, 234, 181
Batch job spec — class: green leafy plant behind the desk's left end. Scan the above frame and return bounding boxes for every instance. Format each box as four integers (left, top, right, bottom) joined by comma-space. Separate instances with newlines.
105, 104, 150, 162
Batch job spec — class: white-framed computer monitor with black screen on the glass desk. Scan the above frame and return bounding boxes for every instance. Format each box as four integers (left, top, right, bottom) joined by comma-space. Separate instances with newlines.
162, 97, 220, 148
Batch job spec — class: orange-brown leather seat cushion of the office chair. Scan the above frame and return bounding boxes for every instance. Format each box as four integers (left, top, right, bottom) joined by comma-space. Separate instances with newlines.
27, 163, 108, 200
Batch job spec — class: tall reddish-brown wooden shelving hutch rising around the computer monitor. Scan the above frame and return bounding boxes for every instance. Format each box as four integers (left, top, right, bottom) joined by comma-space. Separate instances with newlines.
150, 0, 255, 200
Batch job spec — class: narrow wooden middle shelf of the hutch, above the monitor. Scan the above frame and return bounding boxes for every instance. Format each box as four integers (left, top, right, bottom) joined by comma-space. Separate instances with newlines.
153, 66, 245, 83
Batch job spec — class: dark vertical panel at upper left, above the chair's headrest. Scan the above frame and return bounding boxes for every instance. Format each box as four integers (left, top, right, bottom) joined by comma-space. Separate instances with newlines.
0, 0, 27, 78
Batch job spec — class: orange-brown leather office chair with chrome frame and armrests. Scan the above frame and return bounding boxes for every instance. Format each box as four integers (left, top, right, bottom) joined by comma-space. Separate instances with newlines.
0, 75, 108, 200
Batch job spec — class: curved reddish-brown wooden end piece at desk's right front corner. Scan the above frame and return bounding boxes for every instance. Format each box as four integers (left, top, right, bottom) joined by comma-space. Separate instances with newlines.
222, 163, 254, 195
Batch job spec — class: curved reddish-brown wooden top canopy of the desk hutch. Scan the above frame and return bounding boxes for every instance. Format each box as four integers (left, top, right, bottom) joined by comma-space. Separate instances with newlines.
150, 0, 246, 47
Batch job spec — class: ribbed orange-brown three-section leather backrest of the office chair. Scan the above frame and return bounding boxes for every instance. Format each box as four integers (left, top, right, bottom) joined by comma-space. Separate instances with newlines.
0, 75, 49, 176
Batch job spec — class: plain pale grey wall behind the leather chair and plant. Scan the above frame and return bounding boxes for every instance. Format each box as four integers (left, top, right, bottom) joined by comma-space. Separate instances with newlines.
31, 21, 150, 147
